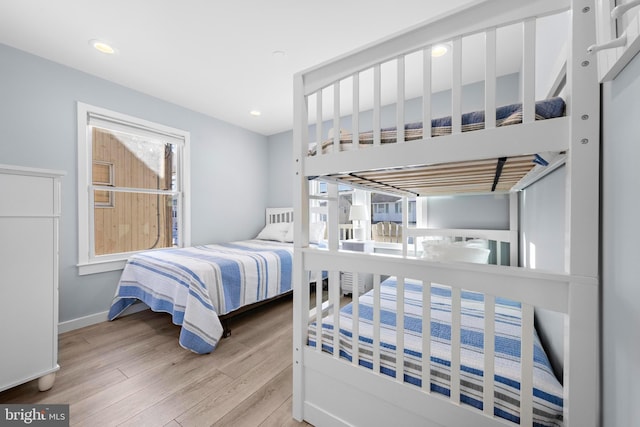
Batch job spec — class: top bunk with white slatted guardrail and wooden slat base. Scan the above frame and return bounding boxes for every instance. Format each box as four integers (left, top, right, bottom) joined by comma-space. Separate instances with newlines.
294, 0, 575, 196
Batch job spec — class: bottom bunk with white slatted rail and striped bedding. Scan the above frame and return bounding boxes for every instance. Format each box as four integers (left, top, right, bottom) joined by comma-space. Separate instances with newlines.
293, 237, 597, 427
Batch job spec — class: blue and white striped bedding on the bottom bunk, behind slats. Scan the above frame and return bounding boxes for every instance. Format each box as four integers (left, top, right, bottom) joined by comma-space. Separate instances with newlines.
309, 278, 563, 426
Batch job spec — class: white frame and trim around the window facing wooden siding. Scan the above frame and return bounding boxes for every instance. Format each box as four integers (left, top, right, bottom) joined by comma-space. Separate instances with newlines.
77, 102, 191, 275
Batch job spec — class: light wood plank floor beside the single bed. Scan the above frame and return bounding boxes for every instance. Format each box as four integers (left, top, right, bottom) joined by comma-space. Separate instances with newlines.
0, 298, 309, 427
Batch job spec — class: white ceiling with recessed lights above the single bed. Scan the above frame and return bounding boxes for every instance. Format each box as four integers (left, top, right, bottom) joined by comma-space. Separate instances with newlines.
0, 0, 478, 135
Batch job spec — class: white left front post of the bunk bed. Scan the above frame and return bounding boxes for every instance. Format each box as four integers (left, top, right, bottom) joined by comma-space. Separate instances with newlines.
292, 74, 308, 421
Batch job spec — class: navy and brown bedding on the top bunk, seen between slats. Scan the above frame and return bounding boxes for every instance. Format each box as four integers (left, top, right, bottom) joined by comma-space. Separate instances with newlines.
309, 97, 565, 156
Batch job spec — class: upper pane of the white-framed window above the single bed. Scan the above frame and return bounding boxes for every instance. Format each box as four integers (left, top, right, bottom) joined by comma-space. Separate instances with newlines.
92, 127, 176, 190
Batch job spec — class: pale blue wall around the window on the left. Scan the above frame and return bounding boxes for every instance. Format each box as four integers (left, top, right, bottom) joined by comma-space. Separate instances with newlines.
0, 44, 269, 322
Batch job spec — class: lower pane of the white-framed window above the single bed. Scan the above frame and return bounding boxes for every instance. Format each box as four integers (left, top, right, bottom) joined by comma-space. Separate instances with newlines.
94, 191, 178, 255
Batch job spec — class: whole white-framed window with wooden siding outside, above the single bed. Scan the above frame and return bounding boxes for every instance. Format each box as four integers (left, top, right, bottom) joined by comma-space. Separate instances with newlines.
78, 103, 190, 274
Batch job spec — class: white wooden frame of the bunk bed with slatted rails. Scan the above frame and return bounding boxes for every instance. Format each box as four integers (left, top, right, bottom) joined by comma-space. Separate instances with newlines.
293, 0, 600, 427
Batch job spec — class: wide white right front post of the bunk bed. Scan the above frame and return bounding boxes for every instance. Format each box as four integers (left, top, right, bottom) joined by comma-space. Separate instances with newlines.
564, 0, 600, 426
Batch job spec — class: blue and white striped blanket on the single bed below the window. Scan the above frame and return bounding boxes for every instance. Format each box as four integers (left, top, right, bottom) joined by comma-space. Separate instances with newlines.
109, 240, 293, 354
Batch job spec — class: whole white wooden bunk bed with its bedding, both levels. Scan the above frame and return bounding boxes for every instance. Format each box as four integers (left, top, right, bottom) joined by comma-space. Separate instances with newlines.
293, 0, 599, 426
